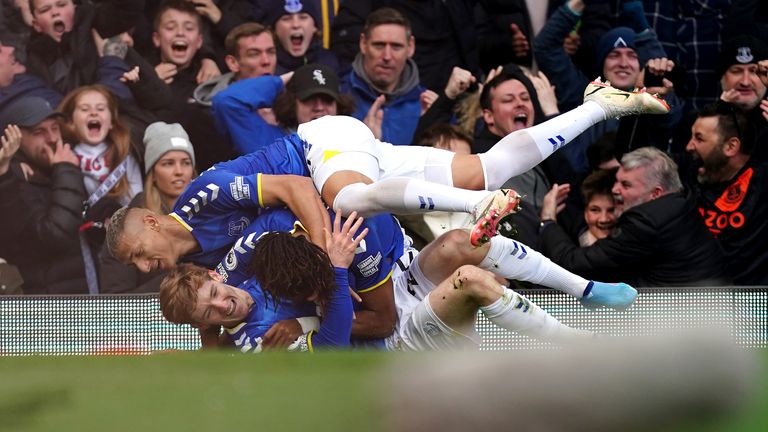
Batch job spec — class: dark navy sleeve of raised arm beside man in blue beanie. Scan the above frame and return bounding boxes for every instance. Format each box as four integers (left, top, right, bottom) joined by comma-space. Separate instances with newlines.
533, 5, 589, 112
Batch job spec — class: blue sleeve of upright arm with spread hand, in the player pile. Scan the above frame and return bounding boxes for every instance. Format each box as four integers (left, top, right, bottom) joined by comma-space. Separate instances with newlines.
307, 267, 352, 352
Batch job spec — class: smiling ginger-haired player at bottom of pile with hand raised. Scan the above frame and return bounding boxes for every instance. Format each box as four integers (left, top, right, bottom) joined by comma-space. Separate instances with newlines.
160, 214, 369, 353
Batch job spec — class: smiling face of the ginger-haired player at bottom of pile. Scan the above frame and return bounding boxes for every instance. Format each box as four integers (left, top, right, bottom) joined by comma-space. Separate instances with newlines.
191, 280, 253, 326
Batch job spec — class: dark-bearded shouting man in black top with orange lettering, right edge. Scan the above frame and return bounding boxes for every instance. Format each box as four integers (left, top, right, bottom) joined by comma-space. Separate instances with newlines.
685, 101, 768, 285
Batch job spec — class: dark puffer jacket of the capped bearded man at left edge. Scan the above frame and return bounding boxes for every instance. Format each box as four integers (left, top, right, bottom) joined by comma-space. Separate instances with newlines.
0, 160, 88, 294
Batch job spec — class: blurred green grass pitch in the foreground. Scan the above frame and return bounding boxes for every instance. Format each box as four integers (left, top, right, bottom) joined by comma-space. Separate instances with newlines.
0, 350, 768, 432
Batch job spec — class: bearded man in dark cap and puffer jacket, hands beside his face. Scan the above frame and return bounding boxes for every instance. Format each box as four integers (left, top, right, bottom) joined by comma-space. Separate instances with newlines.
0, 96, 88, 294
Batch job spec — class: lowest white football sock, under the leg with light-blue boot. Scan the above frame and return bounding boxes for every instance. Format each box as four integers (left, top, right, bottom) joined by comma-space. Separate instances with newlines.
480, 288, 594, 343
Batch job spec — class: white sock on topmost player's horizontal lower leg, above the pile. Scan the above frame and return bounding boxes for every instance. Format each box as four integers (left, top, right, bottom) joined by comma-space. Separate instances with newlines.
333, 177, 489, 217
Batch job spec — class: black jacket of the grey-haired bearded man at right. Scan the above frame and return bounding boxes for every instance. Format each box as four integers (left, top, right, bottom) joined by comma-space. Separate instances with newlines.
541, 192, 729, 287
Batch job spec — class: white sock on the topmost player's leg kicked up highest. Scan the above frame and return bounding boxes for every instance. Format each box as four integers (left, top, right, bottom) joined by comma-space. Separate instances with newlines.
478, 101, 605, 190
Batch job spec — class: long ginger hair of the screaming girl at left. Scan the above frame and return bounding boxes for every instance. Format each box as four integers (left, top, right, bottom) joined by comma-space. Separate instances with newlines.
58, 84, 131, 202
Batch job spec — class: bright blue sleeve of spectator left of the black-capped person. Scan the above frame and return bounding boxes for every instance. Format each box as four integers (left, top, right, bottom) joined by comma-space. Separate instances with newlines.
211, 76, 285, 154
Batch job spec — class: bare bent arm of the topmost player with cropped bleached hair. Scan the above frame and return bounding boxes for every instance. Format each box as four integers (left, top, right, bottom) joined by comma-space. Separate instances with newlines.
261, 174, 330, 249
